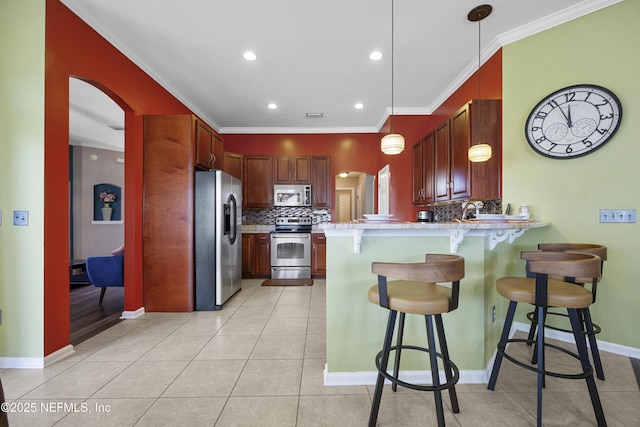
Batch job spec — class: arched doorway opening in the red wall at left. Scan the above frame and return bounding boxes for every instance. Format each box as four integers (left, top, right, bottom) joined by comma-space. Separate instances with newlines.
69, 77, 125, 345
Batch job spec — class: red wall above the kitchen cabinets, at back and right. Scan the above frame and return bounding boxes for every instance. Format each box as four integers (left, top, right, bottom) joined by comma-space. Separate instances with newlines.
222, 51, 502, 221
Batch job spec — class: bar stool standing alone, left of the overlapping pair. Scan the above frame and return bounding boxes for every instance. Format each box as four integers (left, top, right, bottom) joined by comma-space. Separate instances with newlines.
369, 254, 464, 427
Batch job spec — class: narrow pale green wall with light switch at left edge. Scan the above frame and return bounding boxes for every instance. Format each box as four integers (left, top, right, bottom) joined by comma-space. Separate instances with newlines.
0, 0, 45, 358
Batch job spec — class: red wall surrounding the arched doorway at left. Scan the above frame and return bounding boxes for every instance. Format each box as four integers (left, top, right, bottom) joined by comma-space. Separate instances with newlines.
44, 0, 190, 356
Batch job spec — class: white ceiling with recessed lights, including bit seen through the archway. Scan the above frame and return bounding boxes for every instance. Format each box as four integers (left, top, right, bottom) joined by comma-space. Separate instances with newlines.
61, 0, 620, 152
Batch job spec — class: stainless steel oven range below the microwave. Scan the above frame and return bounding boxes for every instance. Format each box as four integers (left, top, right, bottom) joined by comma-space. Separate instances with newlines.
271, 217, 311, 279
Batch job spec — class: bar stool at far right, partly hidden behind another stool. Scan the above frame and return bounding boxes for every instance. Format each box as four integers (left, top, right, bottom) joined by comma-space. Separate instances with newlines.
527, 243, 607, 380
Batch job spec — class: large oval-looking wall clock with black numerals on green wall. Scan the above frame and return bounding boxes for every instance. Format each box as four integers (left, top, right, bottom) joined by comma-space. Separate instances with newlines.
525, 84, 622, 159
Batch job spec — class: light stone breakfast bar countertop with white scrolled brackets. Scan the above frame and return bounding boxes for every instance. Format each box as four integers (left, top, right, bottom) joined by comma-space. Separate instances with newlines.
319, 220, 550, 253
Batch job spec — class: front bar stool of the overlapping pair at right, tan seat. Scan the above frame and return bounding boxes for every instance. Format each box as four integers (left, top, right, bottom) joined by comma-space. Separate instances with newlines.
488, 251, 607, 426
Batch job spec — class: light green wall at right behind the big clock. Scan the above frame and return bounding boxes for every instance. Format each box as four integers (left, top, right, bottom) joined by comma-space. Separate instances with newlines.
502, 0, 640, 348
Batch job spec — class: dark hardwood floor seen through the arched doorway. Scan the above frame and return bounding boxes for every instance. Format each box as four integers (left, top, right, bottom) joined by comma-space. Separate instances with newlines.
69, 284, 124, 345
